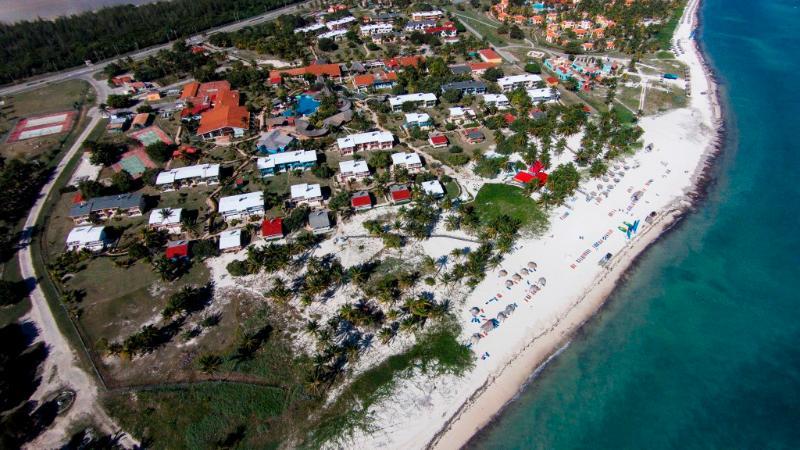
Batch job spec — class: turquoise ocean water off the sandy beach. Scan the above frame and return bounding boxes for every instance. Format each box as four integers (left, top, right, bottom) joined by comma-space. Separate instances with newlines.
469, 0, 800, 449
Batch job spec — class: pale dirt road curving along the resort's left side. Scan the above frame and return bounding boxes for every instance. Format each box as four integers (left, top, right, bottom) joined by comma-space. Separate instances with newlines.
18, 80, 139, 449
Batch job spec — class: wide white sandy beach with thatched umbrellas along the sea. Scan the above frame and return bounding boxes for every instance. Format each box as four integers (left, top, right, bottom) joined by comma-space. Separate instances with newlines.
346, 0, 721, 449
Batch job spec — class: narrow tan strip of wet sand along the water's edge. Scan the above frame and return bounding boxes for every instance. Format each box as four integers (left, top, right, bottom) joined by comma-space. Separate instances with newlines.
425, 0, 726, 449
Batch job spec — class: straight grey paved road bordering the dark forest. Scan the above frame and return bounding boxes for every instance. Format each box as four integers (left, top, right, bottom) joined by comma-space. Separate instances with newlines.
0, 1, 311, 95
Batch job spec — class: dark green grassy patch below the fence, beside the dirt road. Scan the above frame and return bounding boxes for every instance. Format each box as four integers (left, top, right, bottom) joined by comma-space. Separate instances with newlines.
105, 383, 286, 449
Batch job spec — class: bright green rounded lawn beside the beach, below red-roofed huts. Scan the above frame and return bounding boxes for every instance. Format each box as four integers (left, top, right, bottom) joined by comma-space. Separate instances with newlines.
475, 184, 547, 234
